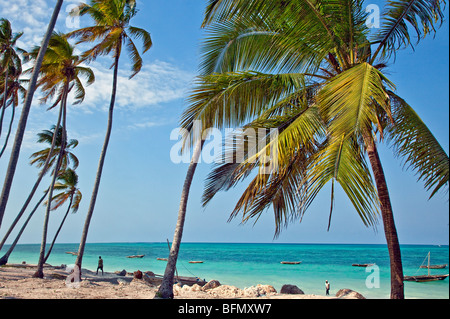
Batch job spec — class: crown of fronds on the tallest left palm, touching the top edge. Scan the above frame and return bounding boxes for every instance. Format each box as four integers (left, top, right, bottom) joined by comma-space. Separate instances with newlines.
67, 0, 152, 78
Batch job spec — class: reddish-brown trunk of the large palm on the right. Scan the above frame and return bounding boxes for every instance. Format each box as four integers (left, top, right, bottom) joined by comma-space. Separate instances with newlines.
367, 139, 405, 299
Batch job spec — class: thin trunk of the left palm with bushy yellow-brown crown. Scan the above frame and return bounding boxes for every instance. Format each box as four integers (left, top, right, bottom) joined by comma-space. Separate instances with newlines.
33, 86, 69, 278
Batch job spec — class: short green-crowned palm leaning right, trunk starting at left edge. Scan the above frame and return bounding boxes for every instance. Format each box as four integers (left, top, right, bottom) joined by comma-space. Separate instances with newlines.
0, 126, 79, 249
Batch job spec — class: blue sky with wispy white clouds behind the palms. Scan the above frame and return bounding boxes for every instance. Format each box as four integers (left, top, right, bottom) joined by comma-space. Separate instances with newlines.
0, 0, 449, 248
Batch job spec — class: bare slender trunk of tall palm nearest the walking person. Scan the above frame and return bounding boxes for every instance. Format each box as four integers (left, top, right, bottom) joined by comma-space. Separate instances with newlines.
75, 50, 120, 279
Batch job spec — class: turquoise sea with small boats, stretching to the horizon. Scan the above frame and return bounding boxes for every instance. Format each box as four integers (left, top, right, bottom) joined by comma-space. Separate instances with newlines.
1, 243, 449, 299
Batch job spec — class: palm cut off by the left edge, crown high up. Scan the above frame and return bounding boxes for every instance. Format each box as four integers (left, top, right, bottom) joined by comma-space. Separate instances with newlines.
0, 18, 25, 136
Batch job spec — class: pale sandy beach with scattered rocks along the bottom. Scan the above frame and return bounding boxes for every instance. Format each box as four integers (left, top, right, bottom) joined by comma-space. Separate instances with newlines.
0, 264, 360, 299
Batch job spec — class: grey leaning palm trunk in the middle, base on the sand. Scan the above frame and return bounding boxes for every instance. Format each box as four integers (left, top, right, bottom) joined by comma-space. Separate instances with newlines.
156, 140, 204, 299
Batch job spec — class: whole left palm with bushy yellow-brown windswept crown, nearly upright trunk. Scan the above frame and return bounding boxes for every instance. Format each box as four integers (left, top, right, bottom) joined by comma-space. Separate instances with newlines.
25, 32, 95, 278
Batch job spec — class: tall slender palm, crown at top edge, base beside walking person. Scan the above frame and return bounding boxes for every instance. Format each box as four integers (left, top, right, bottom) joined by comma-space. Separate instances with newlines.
68, 0, 152, 276
